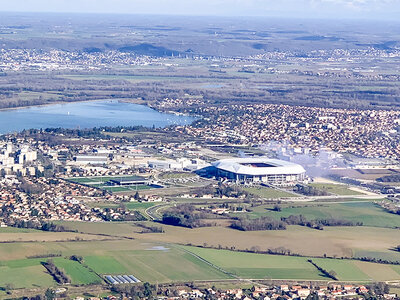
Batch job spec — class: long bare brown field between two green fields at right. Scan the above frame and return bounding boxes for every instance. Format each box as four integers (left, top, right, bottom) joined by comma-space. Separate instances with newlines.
126, 225, 400, 260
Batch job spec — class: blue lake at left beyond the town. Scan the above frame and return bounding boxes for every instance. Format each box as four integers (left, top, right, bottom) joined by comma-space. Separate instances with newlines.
0, 100, 194, 133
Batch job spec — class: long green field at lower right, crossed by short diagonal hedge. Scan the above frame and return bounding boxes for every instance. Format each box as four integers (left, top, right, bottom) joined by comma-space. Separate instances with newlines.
185, 247, 400, 281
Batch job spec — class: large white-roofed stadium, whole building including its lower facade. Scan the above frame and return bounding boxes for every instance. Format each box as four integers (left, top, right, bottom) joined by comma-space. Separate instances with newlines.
212, 157, 306, 185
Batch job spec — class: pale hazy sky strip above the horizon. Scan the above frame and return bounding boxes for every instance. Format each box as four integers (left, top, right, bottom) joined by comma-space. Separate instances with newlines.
0, 0, 400, 19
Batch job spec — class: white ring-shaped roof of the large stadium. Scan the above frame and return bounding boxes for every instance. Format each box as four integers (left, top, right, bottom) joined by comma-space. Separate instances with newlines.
212, 157, 306, 176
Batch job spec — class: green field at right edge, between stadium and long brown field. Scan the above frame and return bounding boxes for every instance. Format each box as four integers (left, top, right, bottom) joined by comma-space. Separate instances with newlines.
249, 201, 400, 228
